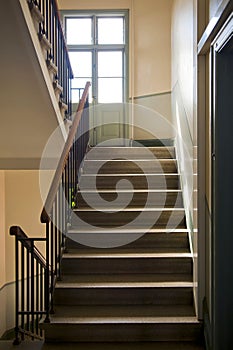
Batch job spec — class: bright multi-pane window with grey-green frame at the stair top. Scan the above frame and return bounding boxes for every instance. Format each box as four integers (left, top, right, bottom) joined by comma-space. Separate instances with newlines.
64, 12, 128, 103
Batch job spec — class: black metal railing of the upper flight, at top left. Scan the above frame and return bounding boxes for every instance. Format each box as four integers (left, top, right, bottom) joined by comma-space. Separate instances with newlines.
28, 0, 73, 118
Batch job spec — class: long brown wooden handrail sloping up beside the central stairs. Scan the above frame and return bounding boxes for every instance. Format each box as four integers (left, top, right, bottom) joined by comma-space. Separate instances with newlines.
40, 82, 91, 223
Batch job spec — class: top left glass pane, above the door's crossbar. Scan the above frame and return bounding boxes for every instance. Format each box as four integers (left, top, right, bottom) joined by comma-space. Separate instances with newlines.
66, 18, 92, 45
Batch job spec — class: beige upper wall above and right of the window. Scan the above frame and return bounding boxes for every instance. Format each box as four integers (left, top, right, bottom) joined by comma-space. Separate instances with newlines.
58, 0, 173, 97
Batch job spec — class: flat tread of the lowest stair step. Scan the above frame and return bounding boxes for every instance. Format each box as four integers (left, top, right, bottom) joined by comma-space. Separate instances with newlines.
52, 305, 195, 318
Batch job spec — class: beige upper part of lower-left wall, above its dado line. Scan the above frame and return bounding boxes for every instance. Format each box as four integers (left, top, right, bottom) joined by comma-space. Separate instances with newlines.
5, 170, 44, 282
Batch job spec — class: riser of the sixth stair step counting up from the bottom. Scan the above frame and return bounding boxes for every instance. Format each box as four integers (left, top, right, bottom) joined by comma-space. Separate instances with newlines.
77, 192, 183, 209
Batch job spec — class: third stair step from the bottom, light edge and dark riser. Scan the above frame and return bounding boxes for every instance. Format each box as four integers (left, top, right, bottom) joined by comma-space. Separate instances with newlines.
62, 253, 192, 274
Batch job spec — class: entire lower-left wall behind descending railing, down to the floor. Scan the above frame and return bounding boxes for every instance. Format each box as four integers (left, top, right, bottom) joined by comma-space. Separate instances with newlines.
0, 170, 45, 336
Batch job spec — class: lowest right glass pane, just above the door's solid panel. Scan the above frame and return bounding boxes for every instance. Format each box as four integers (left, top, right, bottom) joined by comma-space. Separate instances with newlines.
98, 78, 123, 103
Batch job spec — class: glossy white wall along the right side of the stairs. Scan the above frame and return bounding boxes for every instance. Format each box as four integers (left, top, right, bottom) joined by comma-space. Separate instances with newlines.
172, 0, 199, 317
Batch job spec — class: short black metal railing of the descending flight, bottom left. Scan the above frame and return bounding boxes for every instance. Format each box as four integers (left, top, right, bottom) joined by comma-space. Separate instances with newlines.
10, 226, 47, 344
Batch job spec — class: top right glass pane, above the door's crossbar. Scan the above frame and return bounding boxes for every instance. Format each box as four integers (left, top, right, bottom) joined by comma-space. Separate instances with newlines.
98, 18, 124, 44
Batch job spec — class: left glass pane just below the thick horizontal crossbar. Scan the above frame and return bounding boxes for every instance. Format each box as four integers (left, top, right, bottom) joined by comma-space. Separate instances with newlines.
69, 51, 92, 77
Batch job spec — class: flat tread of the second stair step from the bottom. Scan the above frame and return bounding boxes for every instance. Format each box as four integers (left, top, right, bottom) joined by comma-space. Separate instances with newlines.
57, 273, 192, 284
